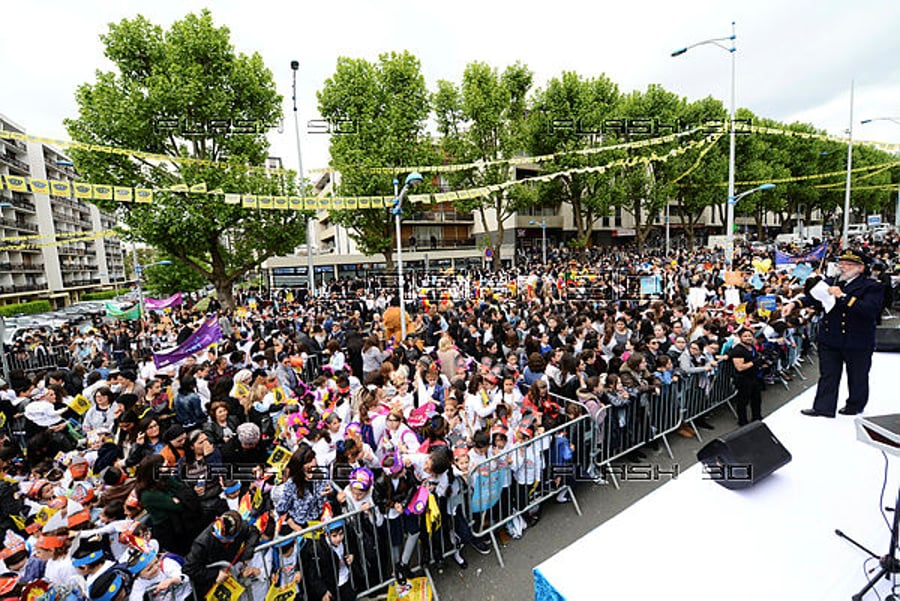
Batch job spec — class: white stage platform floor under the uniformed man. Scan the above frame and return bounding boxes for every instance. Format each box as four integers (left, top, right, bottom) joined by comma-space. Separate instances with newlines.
534, 353, 900, 601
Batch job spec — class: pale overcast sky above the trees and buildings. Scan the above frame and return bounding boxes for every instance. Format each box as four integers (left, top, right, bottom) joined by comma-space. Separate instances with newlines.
0, 0, 900, 178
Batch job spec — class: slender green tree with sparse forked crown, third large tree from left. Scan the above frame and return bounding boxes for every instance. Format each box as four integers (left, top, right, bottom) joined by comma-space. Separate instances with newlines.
432, 62, 534, 269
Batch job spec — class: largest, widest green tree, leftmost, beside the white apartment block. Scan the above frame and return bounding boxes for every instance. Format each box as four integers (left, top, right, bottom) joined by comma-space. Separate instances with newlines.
65, 10, 306, 307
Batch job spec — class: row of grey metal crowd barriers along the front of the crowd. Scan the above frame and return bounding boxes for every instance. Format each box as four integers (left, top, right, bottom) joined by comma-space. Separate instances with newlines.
22, 316, 815, 601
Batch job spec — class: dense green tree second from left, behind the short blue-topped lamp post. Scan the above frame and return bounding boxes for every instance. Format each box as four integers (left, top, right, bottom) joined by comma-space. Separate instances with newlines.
316, 52, 439, 271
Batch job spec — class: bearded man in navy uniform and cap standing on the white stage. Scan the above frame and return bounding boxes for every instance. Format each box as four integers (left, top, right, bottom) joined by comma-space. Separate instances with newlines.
782, 250, 884, 417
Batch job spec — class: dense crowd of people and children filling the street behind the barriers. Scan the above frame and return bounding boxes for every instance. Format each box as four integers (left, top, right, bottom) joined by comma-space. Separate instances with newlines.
0, 231, 898, 601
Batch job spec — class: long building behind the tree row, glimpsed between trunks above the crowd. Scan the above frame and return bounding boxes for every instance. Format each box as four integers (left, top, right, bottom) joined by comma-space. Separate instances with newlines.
263, 164, 800, 287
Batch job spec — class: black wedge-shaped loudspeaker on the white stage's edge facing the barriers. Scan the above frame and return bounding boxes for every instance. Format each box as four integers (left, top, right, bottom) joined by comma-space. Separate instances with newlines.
697, 422, 791, 490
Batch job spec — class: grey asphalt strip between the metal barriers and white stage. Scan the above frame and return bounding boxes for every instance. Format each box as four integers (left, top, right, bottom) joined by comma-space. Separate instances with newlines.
433, 361, 818, 601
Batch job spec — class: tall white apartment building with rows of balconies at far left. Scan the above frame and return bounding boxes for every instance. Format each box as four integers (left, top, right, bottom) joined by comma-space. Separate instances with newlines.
0, 115, 125, 307
